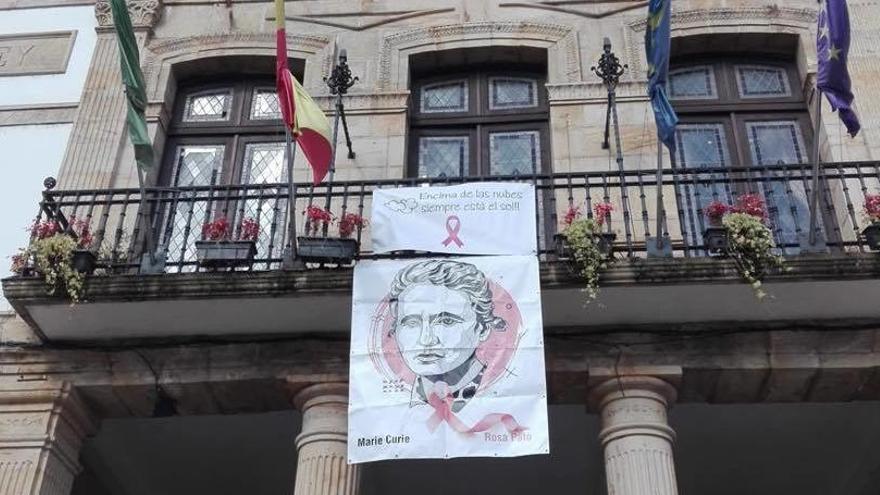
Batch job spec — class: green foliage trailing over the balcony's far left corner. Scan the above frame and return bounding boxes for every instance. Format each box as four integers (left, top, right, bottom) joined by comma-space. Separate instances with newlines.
27, 233, 85, 303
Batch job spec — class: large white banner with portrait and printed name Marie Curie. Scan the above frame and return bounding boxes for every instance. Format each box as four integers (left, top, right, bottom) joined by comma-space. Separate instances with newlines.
348, 256, 550, 463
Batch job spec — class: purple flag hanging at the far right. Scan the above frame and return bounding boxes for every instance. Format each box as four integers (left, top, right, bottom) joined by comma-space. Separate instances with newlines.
816, 0, 861, 137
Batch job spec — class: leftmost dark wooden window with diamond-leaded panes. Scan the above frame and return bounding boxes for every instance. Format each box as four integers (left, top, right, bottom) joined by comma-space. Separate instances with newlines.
160, 79, 287, 270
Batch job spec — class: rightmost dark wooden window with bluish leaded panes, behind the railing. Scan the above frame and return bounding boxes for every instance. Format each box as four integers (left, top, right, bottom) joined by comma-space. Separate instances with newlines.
669, 59, 812, 252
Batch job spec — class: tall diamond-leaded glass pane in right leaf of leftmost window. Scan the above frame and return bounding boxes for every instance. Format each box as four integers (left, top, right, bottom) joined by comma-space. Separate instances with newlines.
238, 143, 287, 268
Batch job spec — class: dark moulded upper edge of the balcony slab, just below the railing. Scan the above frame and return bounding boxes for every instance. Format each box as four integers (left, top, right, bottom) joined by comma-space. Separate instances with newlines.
2, 256, 880, 306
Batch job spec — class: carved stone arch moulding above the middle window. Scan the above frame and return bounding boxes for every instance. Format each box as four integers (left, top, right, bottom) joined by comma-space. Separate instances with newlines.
377, 22, 581, 91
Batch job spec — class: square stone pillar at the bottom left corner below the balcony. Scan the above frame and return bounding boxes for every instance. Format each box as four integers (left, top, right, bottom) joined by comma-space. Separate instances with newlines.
0, 384, 95, 495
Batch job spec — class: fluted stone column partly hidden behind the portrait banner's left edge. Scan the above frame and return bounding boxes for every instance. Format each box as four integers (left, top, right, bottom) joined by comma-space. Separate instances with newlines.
294, 383, 360, 495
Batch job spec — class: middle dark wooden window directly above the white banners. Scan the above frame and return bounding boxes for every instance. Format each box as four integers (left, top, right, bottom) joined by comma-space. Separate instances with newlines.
409, 70, 549, 178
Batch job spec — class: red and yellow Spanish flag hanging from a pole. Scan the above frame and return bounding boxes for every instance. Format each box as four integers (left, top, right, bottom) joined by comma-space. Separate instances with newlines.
275, 0, 333, 184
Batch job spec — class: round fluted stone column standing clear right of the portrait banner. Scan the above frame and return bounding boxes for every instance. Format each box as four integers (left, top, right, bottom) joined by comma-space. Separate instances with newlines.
590, 376, 678, 495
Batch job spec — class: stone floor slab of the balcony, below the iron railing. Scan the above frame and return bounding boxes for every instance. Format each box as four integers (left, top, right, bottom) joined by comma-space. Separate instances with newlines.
3, 254, 880, 342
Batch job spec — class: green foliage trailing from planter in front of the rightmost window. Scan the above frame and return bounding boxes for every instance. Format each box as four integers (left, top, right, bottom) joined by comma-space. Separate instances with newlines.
722, 213, 783, 300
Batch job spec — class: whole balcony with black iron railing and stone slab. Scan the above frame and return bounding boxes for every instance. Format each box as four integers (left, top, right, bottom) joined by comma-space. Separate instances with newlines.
3, 162, 880, 341
